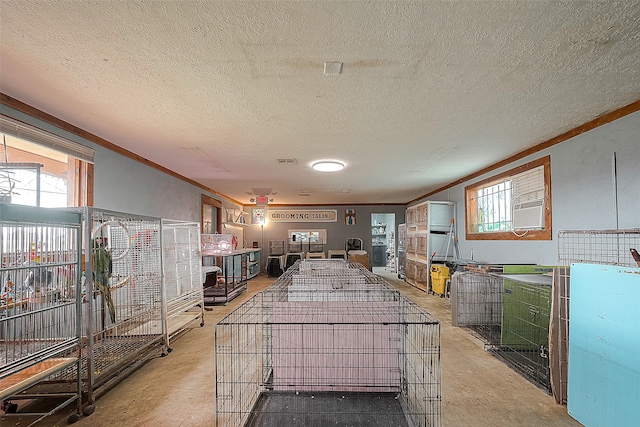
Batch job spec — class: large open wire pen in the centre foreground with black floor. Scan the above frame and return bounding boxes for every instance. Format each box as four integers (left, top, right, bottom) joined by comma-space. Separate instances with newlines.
215, 261, 442, 426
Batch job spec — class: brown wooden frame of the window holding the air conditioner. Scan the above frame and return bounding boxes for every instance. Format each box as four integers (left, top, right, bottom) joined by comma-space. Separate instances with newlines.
464, 156, 552, 240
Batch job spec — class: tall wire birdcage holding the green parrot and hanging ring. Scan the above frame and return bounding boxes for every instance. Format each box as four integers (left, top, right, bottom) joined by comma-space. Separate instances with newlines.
83, 208, 165, 403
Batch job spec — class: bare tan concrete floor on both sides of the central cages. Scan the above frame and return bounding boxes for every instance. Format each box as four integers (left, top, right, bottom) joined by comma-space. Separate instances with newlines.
6, 268, 581, 427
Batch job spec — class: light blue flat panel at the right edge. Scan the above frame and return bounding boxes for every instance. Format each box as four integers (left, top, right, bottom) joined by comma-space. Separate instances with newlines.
567, 264, 640, 426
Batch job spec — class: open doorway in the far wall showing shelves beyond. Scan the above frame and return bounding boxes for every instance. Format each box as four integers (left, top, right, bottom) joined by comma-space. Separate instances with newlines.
371, 213, 396, 273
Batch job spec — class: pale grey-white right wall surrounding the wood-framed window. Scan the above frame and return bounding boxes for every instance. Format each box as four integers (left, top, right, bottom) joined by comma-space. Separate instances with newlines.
422, 112, 640, 265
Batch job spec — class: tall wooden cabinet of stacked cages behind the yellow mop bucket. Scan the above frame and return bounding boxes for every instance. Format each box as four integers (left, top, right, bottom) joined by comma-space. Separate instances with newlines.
405, 201, 455, 291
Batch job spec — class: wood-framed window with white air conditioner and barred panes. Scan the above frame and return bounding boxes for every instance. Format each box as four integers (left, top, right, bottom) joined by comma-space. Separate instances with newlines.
465, 156, 551, 240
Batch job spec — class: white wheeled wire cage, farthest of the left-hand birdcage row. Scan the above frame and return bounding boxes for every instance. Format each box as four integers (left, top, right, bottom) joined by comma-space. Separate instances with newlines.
161, 219, 204, 354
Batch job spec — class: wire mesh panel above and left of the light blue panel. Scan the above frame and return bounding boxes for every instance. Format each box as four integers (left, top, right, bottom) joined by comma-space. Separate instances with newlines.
551, 228, 640, 404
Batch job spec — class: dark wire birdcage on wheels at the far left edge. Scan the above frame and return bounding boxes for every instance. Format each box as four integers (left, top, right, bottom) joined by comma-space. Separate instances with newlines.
0, 204, 88, 425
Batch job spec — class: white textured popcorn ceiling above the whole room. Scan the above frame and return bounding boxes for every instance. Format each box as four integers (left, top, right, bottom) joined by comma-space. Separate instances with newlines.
0, 0, 640, 204
